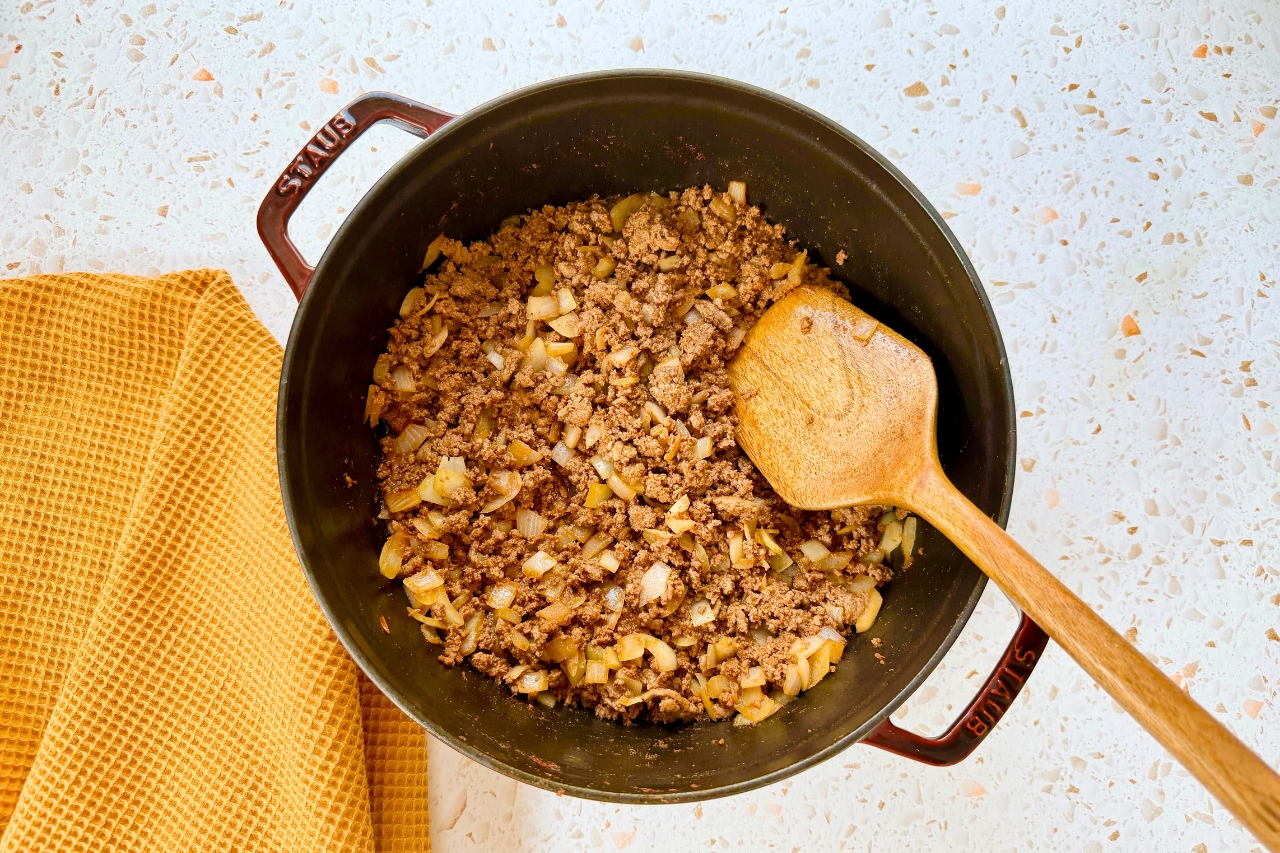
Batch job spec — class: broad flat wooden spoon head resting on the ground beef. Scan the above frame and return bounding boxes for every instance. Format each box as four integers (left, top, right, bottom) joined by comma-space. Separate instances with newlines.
728, 286, 938, 510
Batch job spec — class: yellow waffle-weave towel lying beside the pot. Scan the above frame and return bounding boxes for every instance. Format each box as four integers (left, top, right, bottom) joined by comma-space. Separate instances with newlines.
0, 270, 430, 853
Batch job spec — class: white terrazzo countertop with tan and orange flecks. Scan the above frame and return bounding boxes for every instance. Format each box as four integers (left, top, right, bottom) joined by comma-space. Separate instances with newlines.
0, 0, 1280, 853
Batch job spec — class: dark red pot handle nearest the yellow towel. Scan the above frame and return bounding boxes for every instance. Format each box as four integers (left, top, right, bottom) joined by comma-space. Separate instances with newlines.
257, 92, 453, 301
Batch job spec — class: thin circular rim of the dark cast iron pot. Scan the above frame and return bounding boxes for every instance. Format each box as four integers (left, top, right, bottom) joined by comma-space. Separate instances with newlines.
275, 68, 1018, 804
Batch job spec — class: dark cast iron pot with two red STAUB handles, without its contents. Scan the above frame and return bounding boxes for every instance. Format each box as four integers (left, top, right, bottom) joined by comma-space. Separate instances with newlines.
257, 72, 1046, 803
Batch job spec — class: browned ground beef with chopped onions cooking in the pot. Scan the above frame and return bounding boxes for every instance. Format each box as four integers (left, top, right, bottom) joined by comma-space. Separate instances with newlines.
365, 184, 915, 722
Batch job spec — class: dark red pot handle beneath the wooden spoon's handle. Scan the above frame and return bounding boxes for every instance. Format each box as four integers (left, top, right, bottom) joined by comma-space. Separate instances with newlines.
863, 613, 1048, 767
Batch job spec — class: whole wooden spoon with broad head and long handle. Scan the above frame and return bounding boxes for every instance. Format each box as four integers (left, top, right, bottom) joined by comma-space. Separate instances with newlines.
728, 286, 1280, 853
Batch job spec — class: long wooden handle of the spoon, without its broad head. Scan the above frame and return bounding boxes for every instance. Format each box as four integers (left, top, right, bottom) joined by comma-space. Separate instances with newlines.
905, 467, 1280, 853
